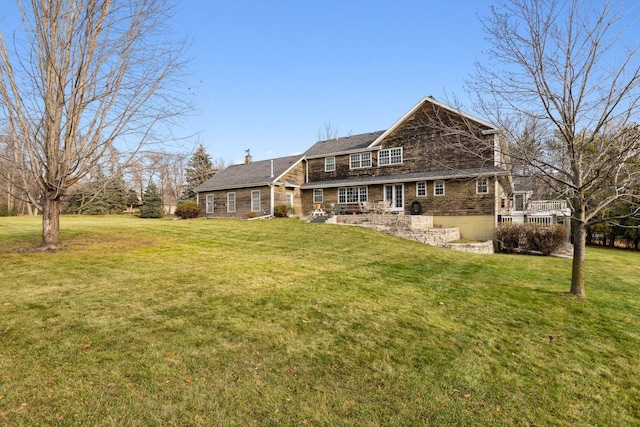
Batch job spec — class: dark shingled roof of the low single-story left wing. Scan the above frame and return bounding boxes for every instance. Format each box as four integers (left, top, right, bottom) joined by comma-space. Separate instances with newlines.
196, 154, 302, 192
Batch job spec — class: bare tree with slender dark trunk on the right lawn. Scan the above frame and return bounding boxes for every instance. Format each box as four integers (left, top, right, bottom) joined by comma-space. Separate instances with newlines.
469, 0, 640, 297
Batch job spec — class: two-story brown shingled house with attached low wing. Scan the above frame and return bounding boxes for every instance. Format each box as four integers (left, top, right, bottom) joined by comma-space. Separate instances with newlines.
197, 97, 511, 240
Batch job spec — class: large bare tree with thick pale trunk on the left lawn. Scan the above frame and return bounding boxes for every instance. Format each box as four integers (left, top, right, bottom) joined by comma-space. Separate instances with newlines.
0, 0, 185, 250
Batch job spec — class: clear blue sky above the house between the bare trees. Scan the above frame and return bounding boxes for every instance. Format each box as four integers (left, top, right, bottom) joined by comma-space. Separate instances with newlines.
168, 0, 491, 162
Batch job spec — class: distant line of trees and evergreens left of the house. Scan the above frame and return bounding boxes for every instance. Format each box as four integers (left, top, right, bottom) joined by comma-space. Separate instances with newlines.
0, 138, 228, 217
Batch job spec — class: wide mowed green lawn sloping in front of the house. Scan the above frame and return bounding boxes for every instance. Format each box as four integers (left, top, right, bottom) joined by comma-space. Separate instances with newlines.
0, 216, 640, 426
